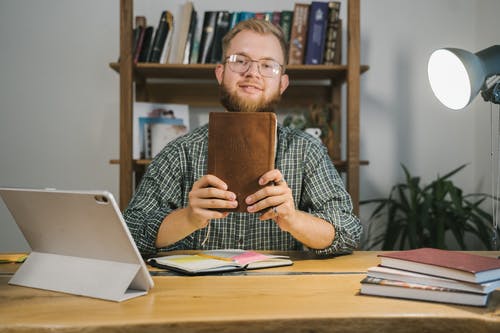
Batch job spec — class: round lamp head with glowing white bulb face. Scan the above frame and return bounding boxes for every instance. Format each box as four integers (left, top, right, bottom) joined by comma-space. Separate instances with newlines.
427, 45, 500, 110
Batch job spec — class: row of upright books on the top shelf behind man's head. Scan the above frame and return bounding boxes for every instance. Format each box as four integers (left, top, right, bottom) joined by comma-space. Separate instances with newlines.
133, 1, 342, 65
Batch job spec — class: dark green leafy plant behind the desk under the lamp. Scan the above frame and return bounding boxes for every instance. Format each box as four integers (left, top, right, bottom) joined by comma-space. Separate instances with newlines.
360, 165, 498, 250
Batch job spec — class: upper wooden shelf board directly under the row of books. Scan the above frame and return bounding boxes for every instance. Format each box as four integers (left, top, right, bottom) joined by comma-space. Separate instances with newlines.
109, 63, 368, 107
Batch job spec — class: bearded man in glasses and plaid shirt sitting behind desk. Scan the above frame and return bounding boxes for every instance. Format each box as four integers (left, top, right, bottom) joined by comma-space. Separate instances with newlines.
124, 19, 361, 255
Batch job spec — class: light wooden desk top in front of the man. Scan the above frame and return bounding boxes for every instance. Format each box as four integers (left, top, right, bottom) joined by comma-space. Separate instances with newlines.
0, 252, 500, 333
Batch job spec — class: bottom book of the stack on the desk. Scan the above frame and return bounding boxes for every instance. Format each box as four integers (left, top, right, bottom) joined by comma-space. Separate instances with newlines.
360, 276, 490, 306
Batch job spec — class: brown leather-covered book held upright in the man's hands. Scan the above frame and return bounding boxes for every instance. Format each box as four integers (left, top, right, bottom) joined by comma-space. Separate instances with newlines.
208, 112, 277, 212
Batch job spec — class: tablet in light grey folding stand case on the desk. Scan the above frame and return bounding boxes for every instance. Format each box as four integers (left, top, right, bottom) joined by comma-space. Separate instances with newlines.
0, 188, 153, 301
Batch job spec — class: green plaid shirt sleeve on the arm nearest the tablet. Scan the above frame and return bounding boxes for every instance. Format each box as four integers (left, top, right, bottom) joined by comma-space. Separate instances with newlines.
123, 147, 186, 255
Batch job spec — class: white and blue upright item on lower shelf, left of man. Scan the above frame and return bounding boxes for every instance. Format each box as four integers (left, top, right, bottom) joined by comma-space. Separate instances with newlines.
132, 102, 190, 159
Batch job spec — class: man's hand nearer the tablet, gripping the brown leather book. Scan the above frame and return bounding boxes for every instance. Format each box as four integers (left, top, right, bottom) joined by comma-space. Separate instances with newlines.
186, 175, 238, 229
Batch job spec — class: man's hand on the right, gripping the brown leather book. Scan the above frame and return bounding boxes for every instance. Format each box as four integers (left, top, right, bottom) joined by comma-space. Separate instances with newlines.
245, 169, 297, 231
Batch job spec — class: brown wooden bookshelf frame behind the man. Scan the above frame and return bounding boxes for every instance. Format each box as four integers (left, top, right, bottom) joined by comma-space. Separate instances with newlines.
110, 0, 368, 213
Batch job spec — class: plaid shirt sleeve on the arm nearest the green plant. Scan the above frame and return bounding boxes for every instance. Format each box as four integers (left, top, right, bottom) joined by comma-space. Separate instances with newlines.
302, 141, 362, 255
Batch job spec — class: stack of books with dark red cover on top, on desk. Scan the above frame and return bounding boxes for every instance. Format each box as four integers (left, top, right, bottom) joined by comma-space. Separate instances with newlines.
360, 248, 500, 306
